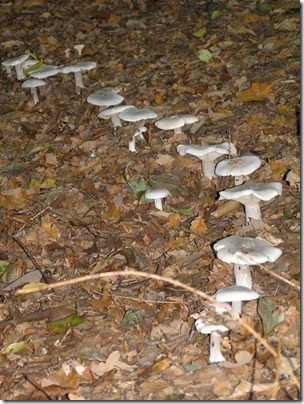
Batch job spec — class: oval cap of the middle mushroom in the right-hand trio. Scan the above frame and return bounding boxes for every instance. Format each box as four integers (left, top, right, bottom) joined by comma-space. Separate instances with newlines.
215, 156, 261, 176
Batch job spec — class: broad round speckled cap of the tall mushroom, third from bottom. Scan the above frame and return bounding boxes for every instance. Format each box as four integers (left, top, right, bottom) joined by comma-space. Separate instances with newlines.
213, 235, 282, 265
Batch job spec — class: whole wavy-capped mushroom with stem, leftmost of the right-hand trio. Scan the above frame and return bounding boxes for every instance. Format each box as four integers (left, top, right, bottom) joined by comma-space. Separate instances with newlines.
176, 142, 237, 179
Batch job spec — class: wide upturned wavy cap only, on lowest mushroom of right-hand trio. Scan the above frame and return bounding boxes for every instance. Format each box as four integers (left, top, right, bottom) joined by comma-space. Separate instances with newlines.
219, 181, 282, 205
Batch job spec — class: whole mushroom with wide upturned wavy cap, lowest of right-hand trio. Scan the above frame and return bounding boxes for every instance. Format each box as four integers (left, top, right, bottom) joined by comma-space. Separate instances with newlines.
219, 181, 282, 223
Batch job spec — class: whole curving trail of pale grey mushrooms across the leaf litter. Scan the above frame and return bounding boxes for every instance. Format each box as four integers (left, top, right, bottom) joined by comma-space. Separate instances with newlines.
2, 54, 282, 363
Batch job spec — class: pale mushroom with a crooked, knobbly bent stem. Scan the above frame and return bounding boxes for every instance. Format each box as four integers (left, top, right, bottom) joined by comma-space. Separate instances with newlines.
118, 107, 157, 152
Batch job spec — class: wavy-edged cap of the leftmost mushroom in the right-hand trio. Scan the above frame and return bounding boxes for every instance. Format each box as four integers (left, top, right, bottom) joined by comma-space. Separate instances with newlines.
176, 142, 237, 161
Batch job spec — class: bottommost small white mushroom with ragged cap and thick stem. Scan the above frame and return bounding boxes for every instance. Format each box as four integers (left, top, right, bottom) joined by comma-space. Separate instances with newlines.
194, 319, 228, 363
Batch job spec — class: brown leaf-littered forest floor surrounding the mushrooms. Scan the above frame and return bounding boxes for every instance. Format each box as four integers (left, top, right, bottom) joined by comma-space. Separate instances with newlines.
0, 0, 300, 400
